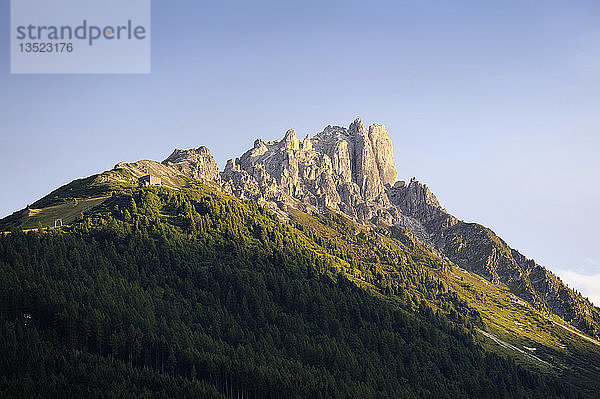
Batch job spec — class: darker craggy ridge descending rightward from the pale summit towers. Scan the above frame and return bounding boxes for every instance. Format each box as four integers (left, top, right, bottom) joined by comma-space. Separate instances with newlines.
390, 179, 600, 338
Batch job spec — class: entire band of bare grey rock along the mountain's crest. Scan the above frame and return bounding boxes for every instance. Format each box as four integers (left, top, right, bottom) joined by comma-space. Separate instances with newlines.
113, 119, 600, 337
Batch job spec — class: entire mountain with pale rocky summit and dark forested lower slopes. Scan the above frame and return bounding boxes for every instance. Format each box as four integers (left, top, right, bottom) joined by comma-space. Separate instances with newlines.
0, 119, 600, 397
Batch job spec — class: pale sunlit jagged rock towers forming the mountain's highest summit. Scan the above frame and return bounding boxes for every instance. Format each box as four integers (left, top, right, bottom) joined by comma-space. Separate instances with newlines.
221, 119, 401, 224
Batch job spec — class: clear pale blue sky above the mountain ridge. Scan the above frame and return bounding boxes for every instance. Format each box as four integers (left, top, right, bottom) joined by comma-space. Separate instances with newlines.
0, 0, 600, 304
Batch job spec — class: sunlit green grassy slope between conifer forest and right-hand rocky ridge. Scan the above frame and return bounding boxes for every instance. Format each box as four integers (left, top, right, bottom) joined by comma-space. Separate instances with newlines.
294, 206, 600, 381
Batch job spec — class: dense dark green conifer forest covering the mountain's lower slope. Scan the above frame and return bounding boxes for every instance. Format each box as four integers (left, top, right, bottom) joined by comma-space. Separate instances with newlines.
0, 185, 593, 398
